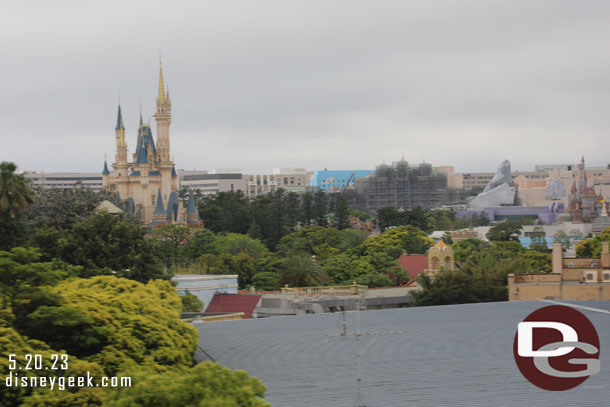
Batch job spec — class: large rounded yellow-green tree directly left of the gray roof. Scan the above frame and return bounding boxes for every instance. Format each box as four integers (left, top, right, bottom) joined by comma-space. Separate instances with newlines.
53, 276, 198, 375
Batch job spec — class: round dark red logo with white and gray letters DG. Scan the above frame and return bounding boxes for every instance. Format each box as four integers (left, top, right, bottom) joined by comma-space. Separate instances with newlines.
513, 305, 600, 391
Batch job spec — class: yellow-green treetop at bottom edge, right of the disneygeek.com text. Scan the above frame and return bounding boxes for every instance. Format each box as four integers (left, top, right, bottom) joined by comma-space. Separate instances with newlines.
104, 362, 271, 407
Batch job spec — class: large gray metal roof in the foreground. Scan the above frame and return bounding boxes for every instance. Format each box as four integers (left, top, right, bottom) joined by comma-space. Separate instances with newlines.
195, 301, 610, 407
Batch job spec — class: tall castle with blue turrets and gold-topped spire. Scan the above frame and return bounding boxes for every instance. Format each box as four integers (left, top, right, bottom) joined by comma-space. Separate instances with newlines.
102, 65, 201, 226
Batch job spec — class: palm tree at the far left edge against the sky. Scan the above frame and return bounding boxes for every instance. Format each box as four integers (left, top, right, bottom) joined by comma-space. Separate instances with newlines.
0, 161, 34, 218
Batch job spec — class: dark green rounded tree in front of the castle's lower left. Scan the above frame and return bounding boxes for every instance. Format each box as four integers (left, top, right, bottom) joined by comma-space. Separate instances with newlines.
58, 211, 163, 282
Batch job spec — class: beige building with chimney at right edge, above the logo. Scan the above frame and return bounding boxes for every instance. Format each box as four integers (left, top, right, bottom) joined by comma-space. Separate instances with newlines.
508, 242, 610, 301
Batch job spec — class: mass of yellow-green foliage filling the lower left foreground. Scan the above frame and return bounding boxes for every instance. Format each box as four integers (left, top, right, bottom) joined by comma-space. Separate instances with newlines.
0, 248, 265, 407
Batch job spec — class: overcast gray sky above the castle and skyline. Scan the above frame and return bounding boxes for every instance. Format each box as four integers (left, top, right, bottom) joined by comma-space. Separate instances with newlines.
0, 0, 610, 173
